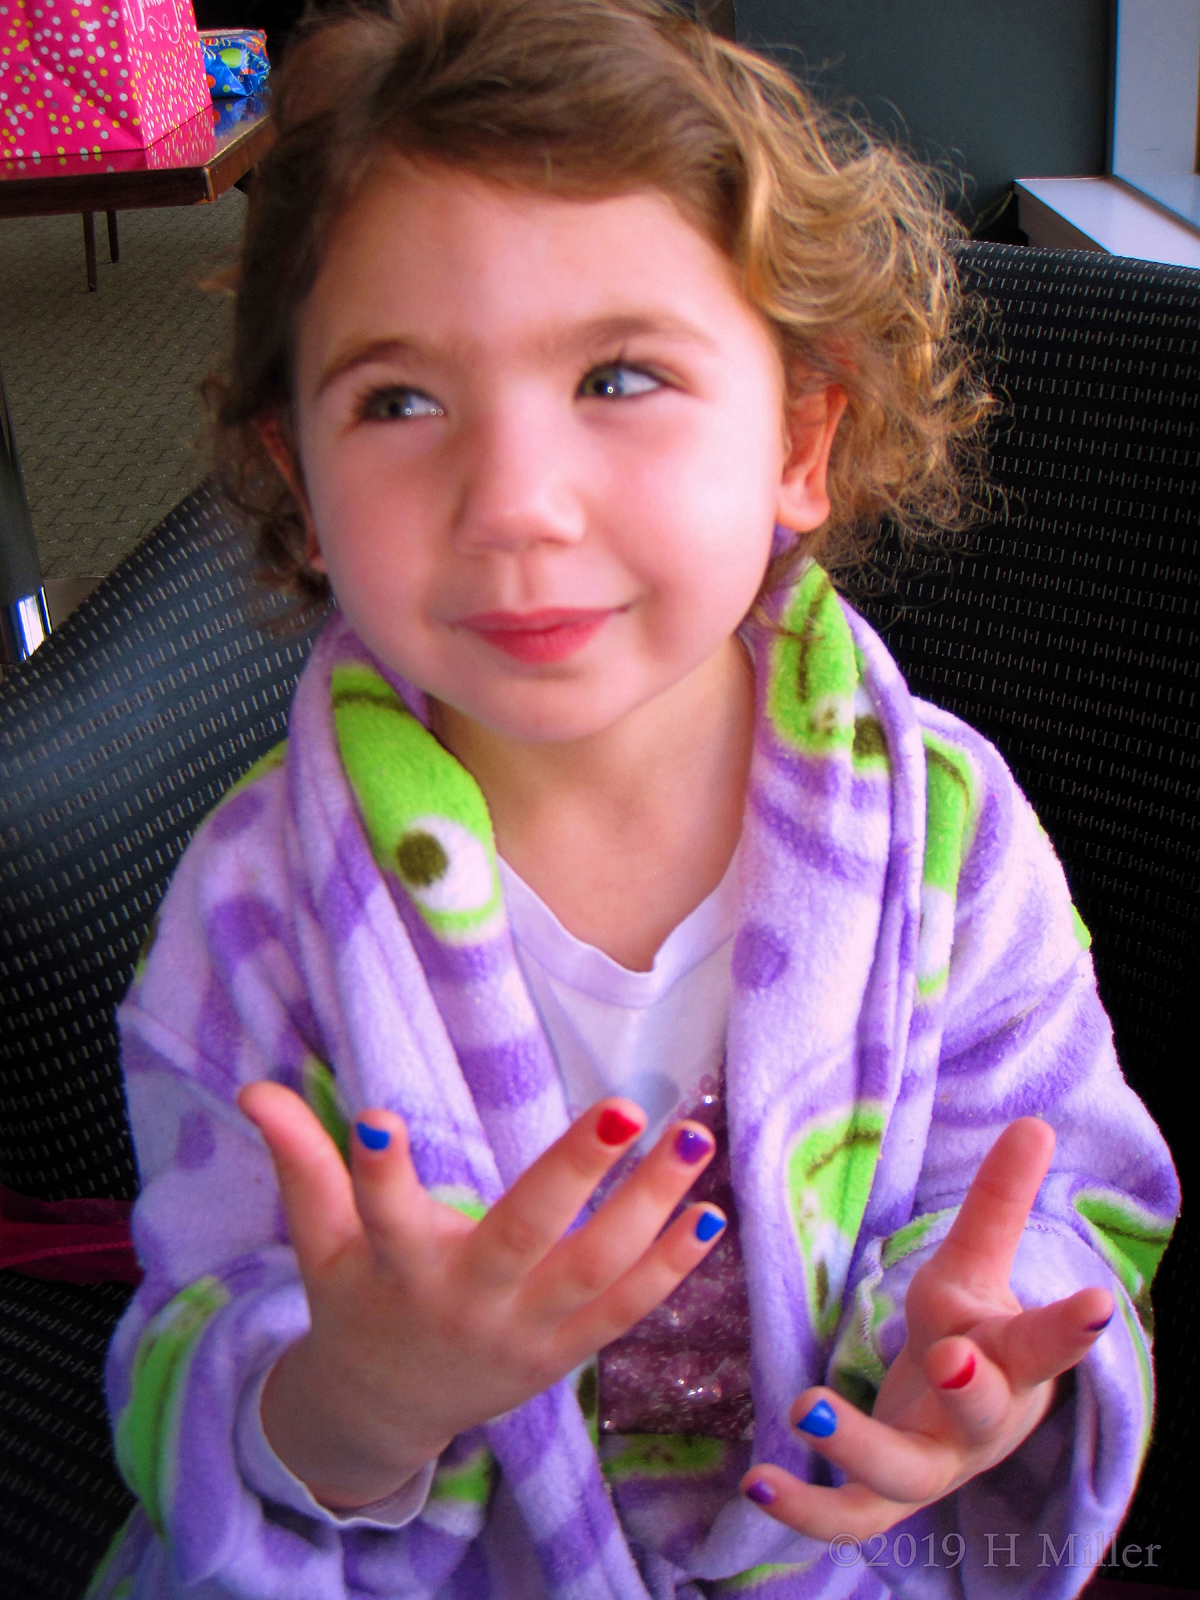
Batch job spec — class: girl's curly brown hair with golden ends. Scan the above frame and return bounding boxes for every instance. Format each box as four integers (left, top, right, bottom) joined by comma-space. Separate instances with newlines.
206, 0, 992, 603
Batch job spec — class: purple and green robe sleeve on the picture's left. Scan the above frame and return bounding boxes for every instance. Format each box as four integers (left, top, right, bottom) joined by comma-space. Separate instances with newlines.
94, 770, 486, 1600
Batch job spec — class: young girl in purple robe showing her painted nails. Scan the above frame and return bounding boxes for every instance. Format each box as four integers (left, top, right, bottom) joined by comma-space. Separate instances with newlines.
93, 0, 1178, 1600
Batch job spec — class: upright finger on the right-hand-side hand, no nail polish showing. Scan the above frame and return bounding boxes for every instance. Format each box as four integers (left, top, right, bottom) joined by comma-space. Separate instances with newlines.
931, 1117, 1054, 1288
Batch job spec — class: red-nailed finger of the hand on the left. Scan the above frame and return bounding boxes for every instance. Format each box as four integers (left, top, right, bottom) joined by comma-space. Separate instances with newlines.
464, 1098, 646, 1290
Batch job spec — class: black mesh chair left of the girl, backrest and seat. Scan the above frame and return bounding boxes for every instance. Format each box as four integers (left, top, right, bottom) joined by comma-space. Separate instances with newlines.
0, 488, 329, 1600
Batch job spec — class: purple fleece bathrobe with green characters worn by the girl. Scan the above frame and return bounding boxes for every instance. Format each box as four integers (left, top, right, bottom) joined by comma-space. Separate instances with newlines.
91, 566, 1179, 1600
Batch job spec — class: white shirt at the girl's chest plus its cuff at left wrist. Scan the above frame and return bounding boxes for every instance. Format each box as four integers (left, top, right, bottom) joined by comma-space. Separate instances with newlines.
235, 851, 738, 1530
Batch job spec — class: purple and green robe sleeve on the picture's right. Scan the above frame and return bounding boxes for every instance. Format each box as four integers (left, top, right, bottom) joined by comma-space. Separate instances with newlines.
829, 707, 1179, 1600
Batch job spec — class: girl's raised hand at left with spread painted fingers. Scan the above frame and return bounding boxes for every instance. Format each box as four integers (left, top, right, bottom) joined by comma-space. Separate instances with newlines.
238, 1082, 725, 1510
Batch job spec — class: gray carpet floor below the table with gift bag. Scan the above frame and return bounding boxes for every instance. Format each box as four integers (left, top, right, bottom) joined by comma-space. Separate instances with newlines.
0, 189, 246, 579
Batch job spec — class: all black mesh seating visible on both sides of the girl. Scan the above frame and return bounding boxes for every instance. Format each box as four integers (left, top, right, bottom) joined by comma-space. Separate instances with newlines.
0, 245, 1200, 1600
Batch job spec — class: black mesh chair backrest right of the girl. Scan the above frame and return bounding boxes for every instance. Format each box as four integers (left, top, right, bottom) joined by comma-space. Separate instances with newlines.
858, 245, 1200, 1587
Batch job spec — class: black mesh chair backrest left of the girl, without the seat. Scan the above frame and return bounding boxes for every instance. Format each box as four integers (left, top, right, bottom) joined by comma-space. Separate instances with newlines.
0, 486, 329, 1200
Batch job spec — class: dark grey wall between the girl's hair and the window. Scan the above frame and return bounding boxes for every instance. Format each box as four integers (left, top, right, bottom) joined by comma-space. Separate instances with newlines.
736, 0, 1109, 228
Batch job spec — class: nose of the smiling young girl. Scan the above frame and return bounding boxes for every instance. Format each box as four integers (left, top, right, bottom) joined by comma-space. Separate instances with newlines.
454, 397, 586, 552
